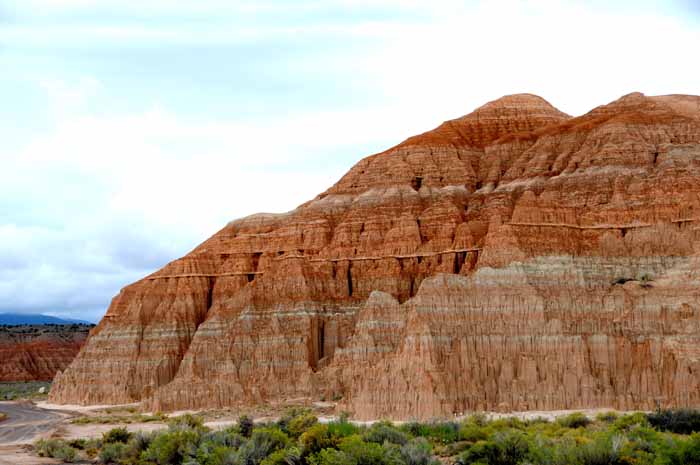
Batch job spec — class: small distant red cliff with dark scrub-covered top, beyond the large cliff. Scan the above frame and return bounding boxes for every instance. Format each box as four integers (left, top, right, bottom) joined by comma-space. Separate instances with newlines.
0, 324, 92, 382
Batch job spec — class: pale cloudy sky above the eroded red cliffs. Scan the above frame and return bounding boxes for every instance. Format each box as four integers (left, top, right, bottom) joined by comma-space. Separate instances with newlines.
0, 0, 700, 321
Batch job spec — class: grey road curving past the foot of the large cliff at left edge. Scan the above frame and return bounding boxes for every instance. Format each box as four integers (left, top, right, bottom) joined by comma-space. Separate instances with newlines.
0, 402, 65, 445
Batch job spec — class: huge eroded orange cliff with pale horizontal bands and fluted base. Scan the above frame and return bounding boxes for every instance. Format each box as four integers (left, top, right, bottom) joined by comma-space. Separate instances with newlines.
50, 93, 700, 419
